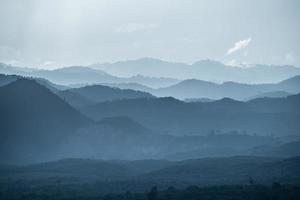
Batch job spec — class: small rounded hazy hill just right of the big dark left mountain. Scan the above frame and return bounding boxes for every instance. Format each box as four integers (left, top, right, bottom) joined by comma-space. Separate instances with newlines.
62, 116, 180, 160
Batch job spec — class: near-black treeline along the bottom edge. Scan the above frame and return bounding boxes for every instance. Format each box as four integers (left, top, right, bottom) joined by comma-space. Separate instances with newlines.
0, 183, 300, 200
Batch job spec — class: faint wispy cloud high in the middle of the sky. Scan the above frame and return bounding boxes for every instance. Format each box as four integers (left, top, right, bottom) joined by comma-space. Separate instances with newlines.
115, 23, 158, 33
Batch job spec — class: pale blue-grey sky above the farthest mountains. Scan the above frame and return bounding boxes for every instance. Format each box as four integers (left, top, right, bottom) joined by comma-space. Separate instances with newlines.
0, 0, 300, 69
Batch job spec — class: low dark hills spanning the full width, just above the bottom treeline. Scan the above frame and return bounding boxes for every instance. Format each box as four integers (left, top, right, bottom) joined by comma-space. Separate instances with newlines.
0, 156, 300, 192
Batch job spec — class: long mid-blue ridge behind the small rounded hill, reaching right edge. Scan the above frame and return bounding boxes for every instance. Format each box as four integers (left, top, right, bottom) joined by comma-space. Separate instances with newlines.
81, 94, 300, 135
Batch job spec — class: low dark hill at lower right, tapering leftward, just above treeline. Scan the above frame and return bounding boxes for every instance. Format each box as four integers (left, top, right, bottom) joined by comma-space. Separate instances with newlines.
142, 156, 300, 185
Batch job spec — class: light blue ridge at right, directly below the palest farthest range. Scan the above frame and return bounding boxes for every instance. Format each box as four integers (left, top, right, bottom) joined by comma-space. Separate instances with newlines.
151, 76, 300, 100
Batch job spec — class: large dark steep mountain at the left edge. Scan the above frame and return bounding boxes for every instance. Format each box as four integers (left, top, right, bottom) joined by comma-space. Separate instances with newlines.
0, 79, 90, 162
